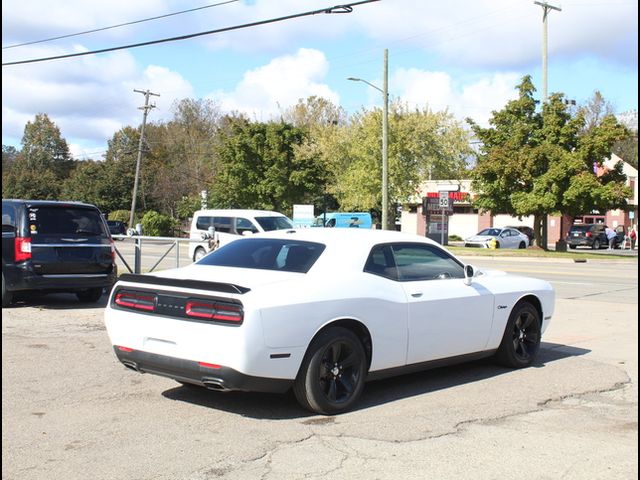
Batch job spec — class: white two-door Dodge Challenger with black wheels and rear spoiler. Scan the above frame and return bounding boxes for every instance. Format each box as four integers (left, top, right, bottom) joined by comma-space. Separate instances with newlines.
105, 228, 555, 414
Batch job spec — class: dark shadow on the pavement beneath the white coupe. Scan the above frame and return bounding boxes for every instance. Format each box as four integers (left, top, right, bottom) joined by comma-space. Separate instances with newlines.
162, 342, 590, 423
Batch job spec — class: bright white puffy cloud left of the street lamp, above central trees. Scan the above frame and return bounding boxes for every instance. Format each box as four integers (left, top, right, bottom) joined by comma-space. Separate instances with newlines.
210, 48, 340, 120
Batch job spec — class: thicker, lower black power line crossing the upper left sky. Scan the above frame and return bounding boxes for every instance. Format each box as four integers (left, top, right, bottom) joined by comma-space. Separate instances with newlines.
2, 0, 380, 67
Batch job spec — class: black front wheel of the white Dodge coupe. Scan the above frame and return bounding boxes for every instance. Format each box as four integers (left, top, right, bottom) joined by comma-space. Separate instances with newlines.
496, 302, 542, 368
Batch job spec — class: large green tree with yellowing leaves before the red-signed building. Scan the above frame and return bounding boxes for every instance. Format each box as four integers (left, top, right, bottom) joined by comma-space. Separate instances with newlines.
469, 76, 629, 248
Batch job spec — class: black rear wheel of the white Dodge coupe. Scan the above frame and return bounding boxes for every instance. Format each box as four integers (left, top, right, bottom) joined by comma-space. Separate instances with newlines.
293, 327, 367, 415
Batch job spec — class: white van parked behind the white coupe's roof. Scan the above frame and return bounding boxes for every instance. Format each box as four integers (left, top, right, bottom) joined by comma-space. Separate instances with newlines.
189, 210, 294, 262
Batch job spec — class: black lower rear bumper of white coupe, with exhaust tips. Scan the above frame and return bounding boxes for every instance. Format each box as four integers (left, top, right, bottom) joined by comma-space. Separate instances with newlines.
113, 346, 293, 393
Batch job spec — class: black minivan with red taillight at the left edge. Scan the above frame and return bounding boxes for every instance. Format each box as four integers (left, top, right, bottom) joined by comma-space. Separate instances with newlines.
2, 199, 117, 307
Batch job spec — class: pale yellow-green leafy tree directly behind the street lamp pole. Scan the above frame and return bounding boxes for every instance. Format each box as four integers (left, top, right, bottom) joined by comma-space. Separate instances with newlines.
332, 102, 471, 223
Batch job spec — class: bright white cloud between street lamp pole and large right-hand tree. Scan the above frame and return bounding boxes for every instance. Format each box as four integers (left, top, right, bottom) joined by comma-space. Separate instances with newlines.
390, 69, 521, 125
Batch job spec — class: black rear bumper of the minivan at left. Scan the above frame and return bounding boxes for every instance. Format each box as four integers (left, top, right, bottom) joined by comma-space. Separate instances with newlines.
2, 262, 118, 292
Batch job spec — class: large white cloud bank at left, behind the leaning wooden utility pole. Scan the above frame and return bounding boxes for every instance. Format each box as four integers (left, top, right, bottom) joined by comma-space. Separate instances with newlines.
2, 47, 193, 150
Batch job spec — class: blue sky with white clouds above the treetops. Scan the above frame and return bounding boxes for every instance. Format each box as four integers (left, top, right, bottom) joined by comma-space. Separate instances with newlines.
2, 0, 638, 158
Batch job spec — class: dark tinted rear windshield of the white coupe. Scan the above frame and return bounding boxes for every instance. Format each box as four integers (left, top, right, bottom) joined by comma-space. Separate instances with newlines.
197, 238, 325, 273
